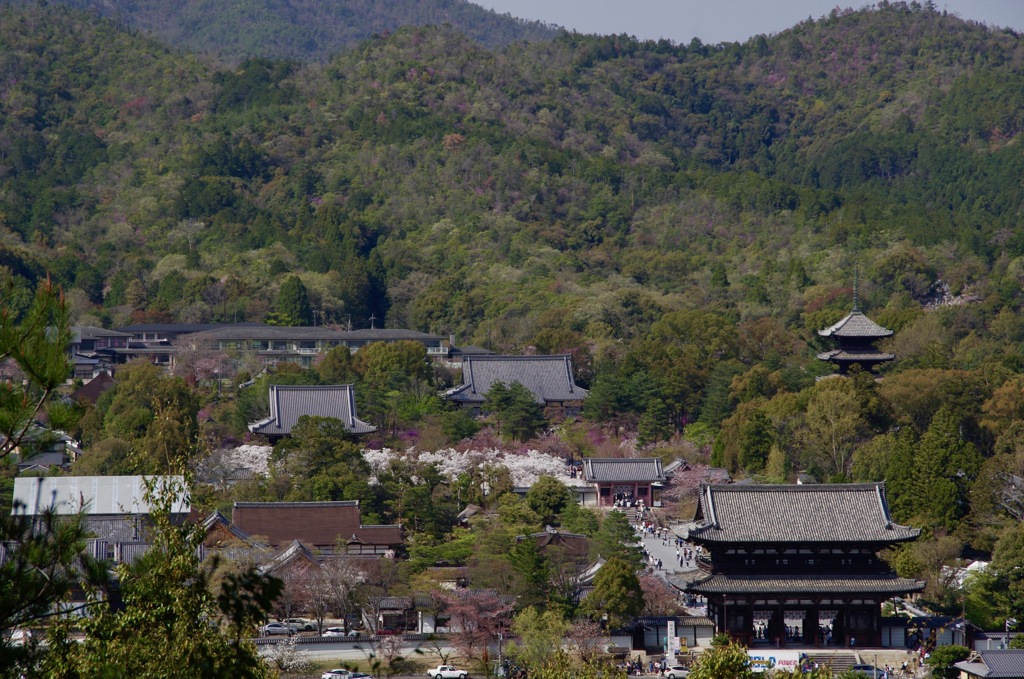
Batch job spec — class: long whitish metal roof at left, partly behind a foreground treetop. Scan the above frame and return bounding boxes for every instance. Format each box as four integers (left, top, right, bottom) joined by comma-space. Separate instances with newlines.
11, 476, 190, 516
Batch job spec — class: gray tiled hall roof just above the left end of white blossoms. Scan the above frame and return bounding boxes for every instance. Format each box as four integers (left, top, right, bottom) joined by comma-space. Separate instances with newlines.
249, 384, 377, 436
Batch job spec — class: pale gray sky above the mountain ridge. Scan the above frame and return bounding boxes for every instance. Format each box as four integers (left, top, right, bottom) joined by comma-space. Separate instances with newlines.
472, 0, 1024, 44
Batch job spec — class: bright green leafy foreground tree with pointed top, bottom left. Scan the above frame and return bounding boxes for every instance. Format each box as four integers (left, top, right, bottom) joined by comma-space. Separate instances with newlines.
42, 477, 282, 678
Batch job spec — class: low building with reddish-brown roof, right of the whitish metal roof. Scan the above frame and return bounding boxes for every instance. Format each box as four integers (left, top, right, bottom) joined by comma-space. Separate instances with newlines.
231, 500, 402, 554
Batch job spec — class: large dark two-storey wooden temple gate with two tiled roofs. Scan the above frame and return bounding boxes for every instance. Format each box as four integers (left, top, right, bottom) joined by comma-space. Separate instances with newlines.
685, 483, 925, 646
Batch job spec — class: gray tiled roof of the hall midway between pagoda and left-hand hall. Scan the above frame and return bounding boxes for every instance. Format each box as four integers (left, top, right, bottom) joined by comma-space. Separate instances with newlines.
444, 355, 590, 404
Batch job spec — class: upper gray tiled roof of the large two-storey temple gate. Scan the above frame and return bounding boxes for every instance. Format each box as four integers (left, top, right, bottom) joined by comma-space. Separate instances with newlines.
689, 483, 921, 544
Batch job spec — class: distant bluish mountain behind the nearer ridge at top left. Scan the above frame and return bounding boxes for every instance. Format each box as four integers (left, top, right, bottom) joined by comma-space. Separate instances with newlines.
2, 0, 557, 62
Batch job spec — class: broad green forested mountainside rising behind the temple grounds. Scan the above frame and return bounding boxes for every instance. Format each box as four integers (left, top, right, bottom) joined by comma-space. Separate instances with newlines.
0, 4, 1024, 340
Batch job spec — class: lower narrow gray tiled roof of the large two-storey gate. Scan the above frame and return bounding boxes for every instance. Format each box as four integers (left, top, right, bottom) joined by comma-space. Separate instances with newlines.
685, 575, 925, 595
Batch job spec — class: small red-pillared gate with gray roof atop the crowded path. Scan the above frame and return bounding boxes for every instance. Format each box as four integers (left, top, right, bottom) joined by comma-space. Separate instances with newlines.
583, 458, 666, 507
